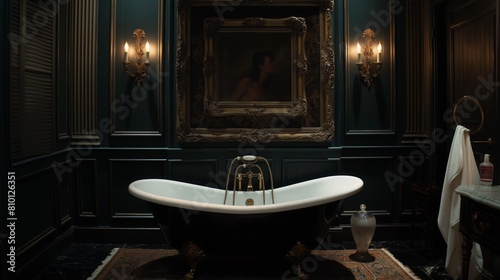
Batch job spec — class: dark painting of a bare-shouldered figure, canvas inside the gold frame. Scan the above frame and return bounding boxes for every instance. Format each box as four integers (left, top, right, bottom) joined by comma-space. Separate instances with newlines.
218, 32, 292, 102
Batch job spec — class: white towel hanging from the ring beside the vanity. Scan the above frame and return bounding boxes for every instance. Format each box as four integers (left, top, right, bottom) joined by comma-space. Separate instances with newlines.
438, 125, 483, 279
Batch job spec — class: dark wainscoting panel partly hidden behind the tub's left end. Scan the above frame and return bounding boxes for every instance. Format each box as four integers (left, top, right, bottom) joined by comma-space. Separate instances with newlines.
109, 159, 167, 220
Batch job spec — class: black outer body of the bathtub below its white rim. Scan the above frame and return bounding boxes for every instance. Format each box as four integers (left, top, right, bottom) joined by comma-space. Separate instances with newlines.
149, 200, 342, 256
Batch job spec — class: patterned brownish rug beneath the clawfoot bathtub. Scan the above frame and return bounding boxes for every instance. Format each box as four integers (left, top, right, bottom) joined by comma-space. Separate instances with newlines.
89, 248, 419, 280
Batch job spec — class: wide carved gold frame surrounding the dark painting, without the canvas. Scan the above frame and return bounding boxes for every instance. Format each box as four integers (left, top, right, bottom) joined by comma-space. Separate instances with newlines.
176, 0, 335, 143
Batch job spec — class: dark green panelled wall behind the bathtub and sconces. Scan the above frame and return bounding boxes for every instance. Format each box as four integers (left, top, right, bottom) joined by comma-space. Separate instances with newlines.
2, 0, 466, 276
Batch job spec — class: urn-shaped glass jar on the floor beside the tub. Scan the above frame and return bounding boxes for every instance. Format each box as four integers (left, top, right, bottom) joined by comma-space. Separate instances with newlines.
349, 204, 377, 262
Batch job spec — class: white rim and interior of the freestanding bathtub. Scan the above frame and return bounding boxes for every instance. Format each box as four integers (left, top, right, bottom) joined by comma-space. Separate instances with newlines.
129, 175, 363, 214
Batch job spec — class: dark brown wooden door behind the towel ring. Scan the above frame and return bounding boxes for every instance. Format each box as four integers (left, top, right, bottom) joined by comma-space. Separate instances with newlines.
443, 0, 500, 184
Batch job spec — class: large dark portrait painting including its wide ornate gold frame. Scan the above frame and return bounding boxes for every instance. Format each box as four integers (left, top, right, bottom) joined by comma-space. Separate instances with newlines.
176, 0, 334, 143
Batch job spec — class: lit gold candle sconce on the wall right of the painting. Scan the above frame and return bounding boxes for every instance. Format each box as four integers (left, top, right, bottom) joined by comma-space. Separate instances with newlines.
356, 28, 382, 88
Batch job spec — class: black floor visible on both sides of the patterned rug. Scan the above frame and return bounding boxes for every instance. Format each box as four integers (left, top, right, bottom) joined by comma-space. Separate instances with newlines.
37, 241, 451, 280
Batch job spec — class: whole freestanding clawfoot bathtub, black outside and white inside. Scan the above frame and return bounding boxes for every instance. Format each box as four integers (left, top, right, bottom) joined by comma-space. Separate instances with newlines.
129, 175, 363, 278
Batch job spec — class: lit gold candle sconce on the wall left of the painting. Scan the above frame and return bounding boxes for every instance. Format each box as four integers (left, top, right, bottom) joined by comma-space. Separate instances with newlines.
123, 28, 150, 87
